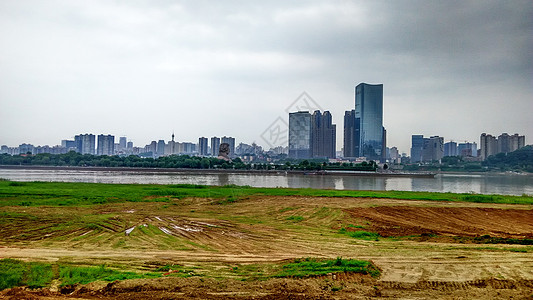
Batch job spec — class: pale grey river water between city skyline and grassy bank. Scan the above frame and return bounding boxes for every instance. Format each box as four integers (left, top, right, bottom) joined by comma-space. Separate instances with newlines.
0, 168, 533, 195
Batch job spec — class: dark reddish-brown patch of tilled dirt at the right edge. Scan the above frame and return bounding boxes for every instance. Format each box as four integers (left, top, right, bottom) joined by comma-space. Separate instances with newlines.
347, 206, 533, 238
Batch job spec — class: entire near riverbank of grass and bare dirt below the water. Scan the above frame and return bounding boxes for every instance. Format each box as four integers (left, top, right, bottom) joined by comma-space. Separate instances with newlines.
0, 181, 533, 299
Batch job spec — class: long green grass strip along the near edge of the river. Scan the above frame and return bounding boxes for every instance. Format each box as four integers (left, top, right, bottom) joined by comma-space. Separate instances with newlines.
0, 181, 533, 206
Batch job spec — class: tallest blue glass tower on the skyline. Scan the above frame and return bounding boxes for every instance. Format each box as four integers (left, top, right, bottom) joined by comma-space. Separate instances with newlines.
355, 83, 386, 161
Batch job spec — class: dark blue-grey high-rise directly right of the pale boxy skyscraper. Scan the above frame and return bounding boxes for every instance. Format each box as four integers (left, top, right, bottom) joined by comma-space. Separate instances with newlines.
311, 110, 337, 158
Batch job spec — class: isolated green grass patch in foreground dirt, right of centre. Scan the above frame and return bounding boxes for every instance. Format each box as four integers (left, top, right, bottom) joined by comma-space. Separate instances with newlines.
274, 257, 380, 278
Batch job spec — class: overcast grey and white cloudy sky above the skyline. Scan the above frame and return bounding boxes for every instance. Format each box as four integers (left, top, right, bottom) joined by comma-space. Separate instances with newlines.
0, 0, 533, 153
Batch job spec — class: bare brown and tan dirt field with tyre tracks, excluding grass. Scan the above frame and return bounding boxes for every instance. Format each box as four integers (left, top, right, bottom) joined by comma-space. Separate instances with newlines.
0, 196, 533, 299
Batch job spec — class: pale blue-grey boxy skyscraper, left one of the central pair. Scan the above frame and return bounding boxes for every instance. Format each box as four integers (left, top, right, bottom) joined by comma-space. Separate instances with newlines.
289, 111, 312, 159
